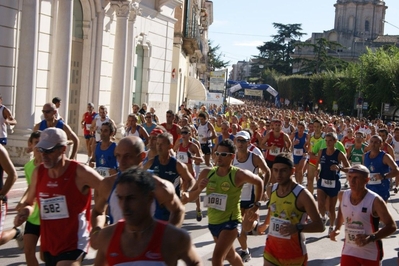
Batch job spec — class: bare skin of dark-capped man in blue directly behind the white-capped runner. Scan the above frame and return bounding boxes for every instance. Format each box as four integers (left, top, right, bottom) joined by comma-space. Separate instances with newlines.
33, 103, 80, 160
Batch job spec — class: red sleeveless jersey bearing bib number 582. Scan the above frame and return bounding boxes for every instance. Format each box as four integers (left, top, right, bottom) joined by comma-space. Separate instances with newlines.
36, 161, 91, 256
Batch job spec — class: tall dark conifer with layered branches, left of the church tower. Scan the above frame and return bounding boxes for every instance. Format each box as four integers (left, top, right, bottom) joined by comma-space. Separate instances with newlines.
257, 23, 305, 75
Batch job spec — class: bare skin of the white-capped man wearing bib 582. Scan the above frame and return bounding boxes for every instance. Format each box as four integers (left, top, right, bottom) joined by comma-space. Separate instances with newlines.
14, 146, 105, 265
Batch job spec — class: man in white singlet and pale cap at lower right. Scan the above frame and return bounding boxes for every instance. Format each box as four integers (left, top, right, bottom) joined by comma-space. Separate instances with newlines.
330, 164, 396, 266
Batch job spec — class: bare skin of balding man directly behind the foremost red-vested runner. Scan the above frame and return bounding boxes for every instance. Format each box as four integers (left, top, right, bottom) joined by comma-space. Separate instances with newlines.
90, 136, 184, 249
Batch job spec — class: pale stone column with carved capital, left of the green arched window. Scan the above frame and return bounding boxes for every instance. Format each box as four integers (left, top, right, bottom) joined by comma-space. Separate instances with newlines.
109, 1, 132, 137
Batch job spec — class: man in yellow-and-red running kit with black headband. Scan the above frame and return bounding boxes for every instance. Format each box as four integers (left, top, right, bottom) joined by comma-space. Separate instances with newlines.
258, 153, 325, 266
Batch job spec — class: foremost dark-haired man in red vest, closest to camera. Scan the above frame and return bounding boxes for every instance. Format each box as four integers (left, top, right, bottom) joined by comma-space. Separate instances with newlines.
94, 168, 202, 266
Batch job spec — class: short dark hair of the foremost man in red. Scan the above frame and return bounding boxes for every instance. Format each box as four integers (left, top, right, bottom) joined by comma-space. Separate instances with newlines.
118, 167, 155, 195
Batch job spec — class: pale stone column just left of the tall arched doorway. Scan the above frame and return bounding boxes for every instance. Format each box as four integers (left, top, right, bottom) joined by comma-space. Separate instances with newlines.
50, 0, 73, 121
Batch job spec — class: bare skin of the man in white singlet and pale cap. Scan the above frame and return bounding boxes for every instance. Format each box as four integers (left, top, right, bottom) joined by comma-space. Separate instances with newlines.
330, 172, 396, 251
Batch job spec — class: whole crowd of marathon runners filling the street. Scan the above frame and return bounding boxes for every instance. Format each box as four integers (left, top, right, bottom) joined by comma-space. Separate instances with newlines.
0, 97, 399, 265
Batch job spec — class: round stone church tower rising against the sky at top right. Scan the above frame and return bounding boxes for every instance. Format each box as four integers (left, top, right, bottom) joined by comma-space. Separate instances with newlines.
334, 0, 388, 40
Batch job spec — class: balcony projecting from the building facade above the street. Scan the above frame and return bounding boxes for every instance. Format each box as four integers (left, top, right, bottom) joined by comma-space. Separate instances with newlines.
183, 19, 201, 56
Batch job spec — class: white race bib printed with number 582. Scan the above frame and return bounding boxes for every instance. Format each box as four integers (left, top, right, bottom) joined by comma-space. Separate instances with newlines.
40, 196, 69, 220
